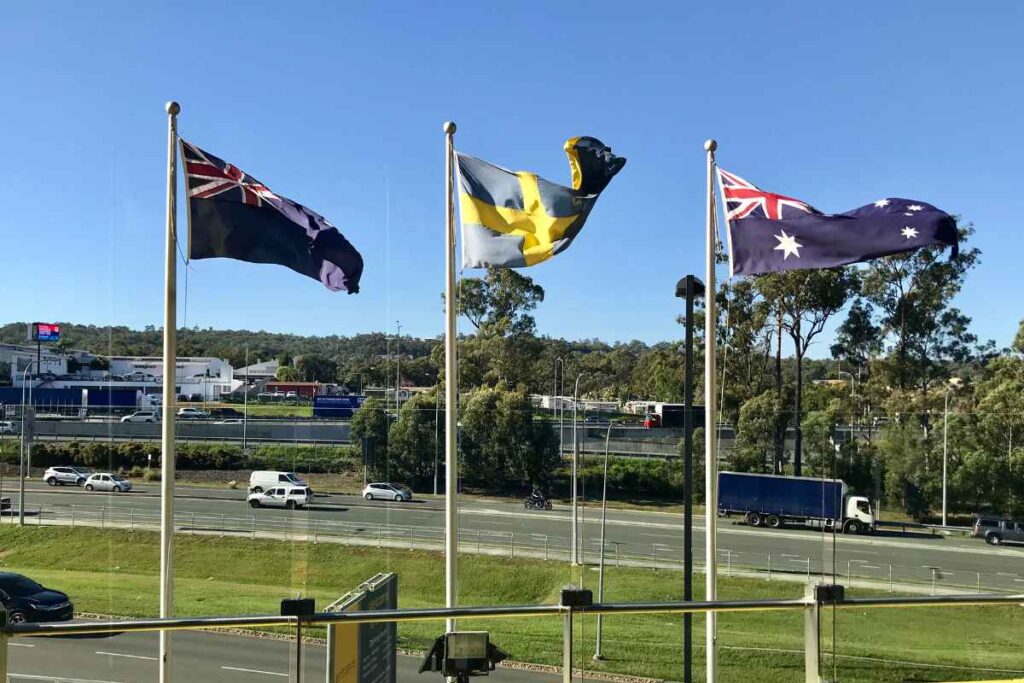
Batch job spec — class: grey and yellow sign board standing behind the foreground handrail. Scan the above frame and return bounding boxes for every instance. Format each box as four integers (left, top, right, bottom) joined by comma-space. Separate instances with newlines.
326, 573, 398, 683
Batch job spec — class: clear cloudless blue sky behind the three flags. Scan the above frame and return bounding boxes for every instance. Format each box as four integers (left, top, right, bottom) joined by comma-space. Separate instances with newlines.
0, 1, 1024, 355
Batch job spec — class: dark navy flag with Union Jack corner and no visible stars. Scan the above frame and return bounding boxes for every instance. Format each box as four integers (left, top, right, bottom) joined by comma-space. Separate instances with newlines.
181, 140, 362, 294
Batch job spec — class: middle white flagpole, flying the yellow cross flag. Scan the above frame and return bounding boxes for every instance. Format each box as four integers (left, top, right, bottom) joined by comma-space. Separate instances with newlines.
444, 121, 459, 632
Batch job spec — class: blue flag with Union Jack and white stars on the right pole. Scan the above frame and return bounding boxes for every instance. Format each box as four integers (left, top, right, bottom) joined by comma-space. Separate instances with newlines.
718, 169, 957, 275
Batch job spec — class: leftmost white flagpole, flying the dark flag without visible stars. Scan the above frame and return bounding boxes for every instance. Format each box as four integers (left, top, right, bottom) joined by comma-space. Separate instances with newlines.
160, 101, 181, 683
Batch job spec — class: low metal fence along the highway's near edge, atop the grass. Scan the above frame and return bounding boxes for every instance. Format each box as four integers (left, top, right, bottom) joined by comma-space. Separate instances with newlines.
9, 505, 1024, 595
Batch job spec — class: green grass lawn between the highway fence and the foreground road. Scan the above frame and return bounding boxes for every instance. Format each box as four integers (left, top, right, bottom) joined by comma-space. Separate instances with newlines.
0, 526, 1024, 682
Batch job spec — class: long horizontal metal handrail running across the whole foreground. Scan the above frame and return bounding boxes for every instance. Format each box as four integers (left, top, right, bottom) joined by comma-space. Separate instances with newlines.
6, 594, 1024, 637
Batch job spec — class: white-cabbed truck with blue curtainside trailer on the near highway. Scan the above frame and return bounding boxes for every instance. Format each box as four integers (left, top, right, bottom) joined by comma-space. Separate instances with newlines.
718, 472, 874, 533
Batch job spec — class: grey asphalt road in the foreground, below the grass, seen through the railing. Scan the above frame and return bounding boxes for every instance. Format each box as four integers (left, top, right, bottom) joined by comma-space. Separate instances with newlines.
7, 624, 561, 683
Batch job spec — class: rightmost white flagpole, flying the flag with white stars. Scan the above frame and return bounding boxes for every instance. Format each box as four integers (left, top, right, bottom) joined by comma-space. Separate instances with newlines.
705, 140, 718, 683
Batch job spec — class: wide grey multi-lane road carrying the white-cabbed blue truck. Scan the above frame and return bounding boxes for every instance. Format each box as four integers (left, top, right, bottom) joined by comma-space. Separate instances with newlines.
3, 480, 1024, 593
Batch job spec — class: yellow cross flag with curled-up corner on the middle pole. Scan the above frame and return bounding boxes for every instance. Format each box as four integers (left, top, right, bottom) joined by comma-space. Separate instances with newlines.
457, 137, 626, 268
